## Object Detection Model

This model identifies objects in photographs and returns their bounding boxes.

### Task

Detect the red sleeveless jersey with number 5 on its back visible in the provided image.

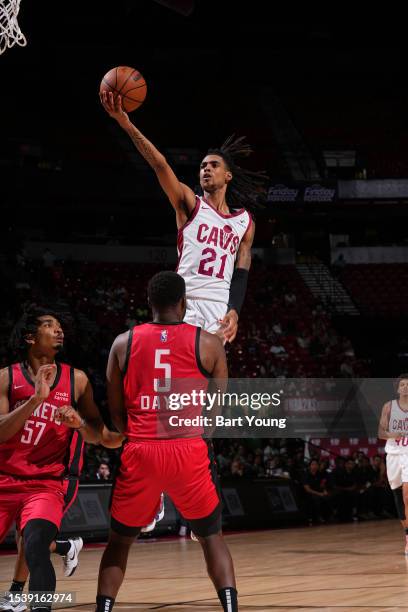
[123,322,208,440]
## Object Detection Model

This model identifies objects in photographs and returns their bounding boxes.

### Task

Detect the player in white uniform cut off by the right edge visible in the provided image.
[378,374,408,555]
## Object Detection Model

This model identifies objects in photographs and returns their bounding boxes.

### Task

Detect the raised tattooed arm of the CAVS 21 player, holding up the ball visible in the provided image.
[101,91,195,227]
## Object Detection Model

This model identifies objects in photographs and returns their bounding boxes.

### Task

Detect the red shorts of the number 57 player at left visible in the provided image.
[0,474,78,542]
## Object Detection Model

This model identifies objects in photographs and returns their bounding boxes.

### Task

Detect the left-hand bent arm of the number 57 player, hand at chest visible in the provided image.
[0,364,56,443]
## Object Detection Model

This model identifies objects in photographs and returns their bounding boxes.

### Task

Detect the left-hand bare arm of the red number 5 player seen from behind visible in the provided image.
[106,332,130,434]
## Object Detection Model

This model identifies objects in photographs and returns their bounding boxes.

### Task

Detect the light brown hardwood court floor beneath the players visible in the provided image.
[0,520,408,612]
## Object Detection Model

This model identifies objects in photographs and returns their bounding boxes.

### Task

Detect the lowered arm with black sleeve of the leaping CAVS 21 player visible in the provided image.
[221,222,255,342]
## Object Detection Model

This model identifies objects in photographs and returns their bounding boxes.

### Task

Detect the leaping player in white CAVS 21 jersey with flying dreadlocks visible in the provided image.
[101,92,266,342]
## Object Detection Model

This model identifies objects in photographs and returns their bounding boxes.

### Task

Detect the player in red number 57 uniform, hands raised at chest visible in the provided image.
[0,308,123,610]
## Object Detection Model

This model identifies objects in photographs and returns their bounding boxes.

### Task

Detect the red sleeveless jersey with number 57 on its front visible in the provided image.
[0,363,83,478]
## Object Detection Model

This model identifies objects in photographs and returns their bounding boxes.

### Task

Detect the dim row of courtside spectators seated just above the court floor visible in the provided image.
[81,438,395,525]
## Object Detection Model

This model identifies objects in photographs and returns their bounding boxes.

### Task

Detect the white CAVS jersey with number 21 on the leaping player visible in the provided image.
[177,196,252,305]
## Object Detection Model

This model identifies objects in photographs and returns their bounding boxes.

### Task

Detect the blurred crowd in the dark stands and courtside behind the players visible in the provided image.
[0,249,392,521]
